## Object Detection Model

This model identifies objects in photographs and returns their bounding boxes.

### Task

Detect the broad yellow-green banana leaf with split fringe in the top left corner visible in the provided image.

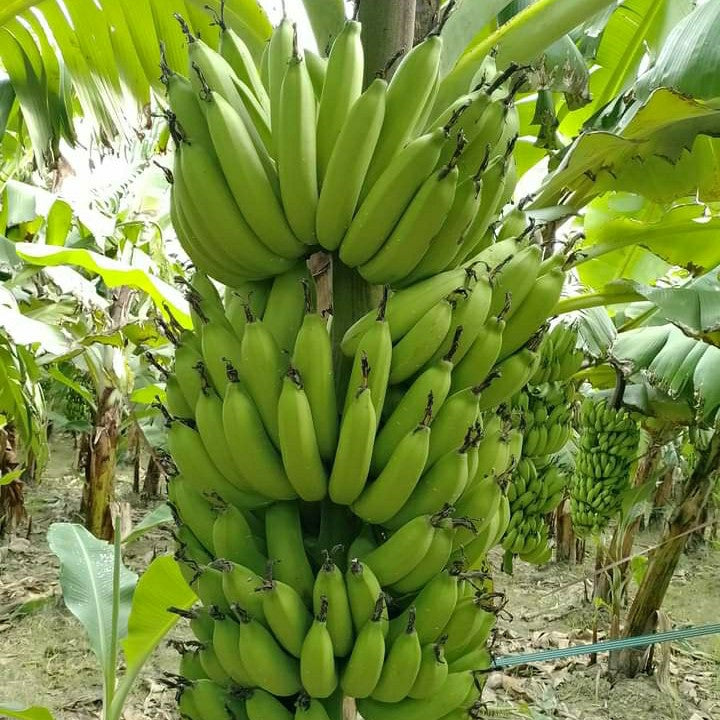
[0,0,271,163]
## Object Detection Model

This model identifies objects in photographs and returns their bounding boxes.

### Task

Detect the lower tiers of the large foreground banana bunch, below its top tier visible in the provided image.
[166,258,556,720]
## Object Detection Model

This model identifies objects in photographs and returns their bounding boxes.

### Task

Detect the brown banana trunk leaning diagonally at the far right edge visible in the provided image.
[610,431,720,677]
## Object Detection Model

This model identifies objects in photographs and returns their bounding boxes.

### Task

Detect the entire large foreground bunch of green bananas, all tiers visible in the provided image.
[160,8,564,720]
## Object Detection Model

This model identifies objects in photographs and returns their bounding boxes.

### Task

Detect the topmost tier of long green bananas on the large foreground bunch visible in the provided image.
[164,11,521,286]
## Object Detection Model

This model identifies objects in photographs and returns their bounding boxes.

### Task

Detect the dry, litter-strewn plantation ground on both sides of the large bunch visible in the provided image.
[0,438,720,720]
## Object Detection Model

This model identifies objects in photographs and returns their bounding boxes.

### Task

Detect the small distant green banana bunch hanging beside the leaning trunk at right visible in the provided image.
[570,398,640,535]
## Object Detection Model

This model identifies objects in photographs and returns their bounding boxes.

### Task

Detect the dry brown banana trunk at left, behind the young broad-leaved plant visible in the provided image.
[81,387,120,540]
